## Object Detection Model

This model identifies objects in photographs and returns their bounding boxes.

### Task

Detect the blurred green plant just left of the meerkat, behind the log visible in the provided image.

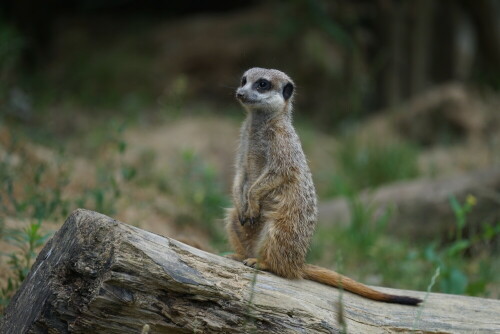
[170,149,229,247]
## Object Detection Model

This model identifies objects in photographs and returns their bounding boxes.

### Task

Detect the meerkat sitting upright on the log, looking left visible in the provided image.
[226,68,421,305]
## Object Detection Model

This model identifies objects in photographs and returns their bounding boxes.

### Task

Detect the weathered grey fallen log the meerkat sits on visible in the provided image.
[0,209,500,333]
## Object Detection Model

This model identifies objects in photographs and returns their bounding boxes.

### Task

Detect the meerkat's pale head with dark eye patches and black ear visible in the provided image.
[236,67,295,112]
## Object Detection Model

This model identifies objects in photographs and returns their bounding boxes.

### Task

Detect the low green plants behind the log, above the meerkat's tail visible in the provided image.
[309,196,500,296]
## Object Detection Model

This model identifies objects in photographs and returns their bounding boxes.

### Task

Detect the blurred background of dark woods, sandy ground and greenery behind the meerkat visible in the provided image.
[0,0,500,312]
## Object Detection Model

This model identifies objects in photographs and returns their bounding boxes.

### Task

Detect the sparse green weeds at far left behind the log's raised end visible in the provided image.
[0,123,136,314]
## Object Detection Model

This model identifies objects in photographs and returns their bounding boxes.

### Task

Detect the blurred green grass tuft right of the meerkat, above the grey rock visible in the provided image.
[322,138,418,197]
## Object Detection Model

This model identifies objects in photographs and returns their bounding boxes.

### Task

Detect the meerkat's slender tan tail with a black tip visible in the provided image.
[304,264,422,306]
